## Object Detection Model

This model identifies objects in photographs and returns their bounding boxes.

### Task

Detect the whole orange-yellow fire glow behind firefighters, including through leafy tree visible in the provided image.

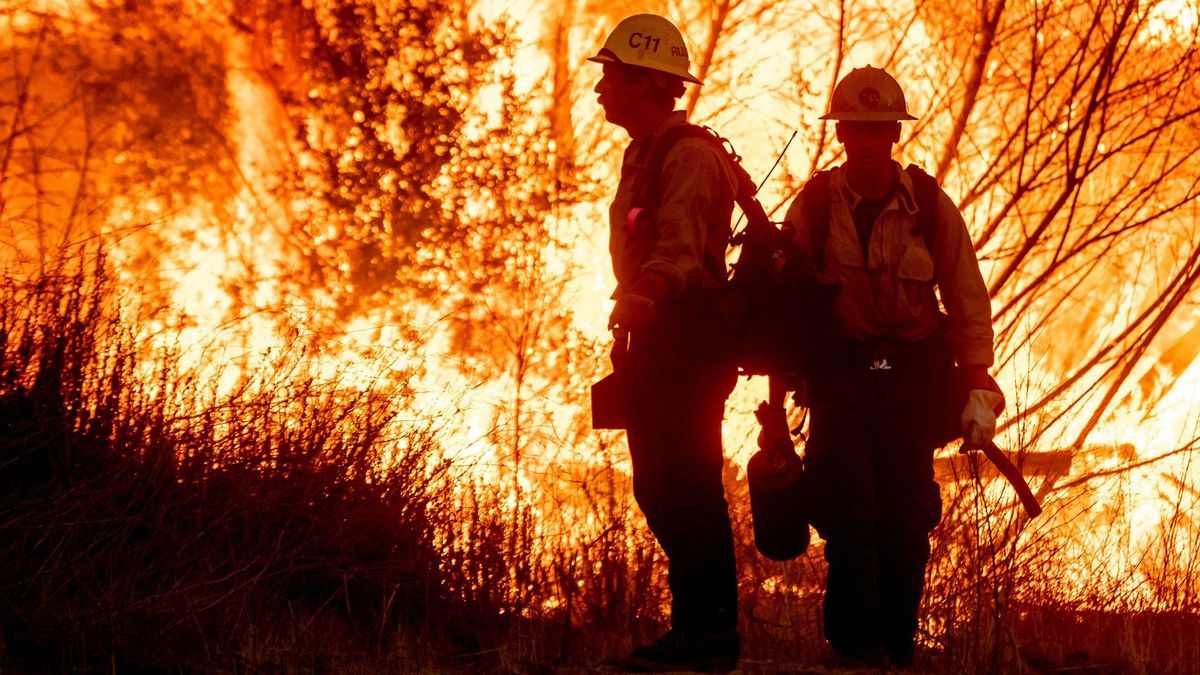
[7,0,1200,629]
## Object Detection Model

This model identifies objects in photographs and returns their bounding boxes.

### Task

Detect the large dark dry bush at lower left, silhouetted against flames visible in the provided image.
[0,258,450,671]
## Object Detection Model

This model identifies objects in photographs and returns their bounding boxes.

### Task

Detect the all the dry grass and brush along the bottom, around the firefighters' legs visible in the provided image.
[0,254,1200,673]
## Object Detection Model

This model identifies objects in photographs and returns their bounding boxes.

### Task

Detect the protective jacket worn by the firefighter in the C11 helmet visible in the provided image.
[608,110,737,298]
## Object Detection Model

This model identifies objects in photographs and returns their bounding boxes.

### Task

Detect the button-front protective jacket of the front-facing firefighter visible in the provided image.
[786,162,994,366]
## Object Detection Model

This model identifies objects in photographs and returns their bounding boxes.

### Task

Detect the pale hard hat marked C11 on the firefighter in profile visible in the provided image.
[588,14,703,84]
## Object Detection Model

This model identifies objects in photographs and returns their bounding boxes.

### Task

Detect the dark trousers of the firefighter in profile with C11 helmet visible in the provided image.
[628,302,738,633]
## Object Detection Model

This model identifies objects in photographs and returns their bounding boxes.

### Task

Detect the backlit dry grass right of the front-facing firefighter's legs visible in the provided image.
[919,460,1200,673]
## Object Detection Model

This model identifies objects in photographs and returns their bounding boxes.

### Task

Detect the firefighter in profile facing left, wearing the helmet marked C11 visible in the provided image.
[589,14,739,673]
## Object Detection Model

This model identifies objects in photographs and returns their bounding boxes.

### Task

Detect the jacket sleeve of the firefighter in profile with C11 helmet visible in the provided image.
[640,138,734,297]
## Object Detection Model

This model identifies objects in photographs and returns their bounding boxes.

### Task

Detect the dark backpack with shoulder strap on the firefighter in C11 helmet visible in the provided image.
[631,124,832,375]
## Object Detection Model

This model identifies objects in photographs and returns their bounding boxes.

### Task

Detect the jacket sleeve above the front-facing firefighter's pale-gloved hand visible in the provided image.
[934,191,995,368]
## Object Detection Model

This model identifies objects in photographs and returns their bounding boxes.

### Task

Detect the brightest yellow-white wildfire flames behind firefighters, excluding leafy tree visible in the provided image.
[4,0,1200,614]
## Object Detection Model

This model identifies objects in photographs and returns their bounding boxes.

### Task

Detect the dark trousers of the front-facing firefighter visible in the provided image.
[805,334,953,665]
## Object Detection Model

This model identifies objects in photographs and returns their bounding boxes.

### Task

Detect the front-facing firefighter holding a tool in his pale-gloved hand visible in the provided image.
[786,66,1003,668]
